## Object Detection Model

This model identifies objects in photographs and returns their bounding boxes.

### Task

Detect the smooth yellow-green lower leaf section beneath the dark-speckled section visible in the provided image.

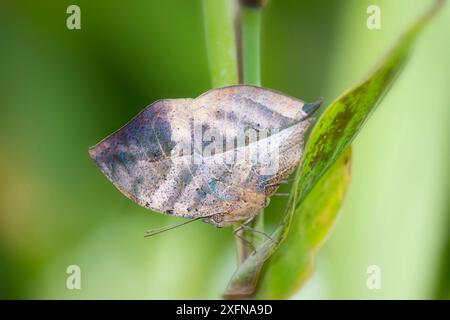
[256,148,351,299]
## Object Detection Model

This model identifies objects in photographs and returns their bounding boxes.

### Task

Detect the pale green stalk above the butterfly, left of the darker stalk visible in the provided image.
[203,0,239,88]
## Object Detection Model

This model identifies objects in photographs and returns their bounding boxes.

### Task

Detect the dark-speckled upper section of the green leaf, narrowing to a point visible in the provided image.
[300,1,442,197]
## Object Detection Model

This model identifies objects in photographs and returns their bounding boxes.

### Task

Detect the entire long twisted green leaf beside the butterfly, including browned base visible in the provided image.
[225,1,443,298]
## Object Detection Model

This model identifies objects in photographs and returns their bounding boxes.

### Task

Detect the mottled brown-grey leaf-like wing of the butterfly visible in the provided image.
[90,86,318,224]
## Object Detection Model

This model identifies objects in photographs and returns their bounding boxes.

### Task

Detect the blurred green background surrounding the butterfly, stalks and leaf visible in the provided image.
[0,0,450,299]
